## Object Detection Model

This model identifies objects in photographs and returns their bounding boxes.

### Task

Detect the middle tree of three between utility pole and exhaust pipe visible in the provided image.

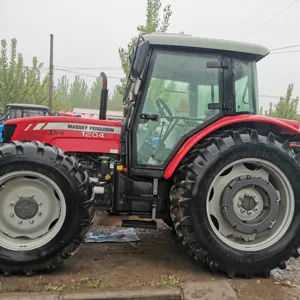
[69,75,89,108]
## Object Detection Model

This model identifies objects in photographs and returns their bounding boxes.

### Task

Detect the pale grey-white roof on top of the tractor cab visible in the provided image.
[143,32,270,61]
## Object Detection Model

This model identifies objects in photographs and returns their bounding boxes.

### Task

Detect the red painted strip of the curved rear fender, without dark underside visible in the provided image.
[164,115,300,179]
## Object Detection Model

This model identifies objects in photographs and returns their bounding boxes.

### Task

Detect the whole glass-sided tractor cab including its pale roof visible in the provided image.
[124,33,269,174]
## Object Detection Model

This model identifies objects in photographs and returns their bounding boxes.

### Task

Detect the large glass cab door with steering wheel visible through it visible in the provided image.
[132,51,223,173]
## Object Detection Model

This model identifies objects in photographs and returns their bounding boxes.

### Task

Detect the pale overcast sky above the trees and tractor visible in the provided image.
[0,0,300,108]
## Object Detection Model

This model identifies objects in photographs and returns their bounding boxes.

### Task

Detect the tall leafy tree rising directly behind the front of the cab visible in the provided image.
[117,0,172,95]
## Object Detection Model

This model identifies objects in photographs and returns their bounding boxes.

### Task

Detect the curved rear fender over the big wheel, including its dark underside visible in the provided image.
[164,115,300,179]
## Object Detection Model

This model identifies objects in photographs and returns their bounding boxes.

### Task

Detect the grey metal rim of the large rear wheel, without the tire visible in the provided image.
[206,158,295,251]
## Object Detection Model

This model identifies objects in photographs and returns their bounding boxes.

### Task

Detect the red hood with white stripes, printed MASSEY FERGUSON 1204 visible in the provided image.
[5,116,122,154]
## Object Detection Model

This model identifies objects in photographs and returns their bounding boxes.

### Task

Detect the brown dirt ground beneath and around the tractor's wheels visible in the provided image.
[0,215,300,300]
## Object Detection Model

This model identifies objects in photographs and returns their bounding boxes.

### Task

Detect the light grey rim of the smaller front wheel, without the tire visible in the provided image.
[0,171,66,251]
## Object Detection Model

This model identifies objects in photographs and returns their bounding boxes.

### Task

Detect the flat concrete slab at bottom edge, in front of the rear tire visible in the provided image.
[183,280,237,300]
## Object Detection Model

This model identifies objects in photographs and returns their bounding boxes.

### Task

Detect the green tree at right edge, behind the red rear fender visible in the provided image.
[261,83,300,121]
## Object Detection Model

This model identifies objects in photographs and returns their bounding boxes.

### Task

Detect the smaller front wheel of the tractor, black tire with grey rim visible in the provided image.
[0,141,94,275]
